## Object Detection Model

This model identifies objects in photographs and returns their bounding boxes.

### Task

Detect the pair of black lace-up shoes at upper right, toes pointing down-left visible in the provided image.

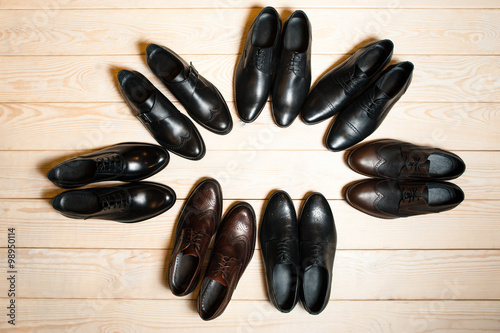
[300,39,413,152]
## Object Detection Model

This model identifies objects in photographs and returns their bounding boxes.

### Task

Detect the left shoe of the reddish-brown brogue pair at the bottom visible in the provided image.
[168,179,222,296]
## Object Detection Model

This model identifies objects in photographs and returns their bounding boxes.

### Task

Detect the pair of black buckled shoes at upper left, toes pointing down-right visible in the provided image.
[118,44,233,160]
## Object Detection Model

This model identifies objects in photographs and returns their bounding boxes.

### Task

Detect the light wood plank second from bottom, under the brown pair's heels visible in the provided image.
[0,249,500,300]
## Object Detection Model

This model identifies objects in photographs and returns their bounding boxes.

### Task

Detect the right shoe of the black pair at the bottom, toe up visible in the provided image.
[299,193,337,314]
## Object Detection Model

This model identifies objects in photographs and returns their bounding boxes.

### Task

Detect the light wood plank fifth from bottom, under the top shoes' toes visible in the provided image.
[0,101,500,150]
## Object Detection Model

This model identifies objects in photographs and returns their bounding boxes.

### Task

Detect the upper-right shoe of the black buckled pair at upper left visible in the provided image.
[146,44,233,134]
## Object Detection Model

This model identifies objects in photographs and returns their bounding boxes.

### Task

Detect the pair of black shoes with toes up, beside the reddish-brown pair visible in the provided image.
[259,191,337,314]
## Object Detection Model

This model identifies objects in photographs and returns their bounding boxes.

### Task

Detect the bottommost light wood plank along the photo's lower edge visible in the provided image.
[0,299,500,333]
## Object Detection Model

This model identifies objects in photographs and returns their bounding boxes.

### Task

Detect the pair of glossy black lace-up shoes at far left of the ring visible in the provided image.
[47,143,176,223]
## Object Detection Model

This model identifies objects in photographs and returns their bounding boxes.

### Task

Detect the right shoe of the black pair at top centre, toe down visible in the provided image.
[272,10,312,127]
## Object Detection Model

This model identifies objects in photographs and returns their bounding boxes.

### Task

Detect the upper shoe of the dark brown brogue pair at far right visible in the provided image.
[347,139,465,180]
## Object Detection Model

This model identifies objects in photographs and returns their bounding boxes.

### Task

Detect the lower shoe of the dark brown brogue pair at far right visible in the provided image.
[346,179,464,219]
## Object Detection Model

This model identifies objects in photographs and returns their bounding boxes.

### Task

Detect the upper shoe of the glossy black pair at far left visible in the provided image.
[47,142,169,188]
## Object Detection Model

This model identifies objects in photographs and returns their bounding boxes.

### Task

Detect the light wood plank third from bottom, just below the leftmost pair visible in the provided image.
[0,199,500,249]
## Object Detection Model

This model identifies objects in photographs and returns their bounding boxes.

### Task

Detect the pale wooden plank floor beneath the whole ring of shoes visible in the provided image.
[0,0,500,333]
